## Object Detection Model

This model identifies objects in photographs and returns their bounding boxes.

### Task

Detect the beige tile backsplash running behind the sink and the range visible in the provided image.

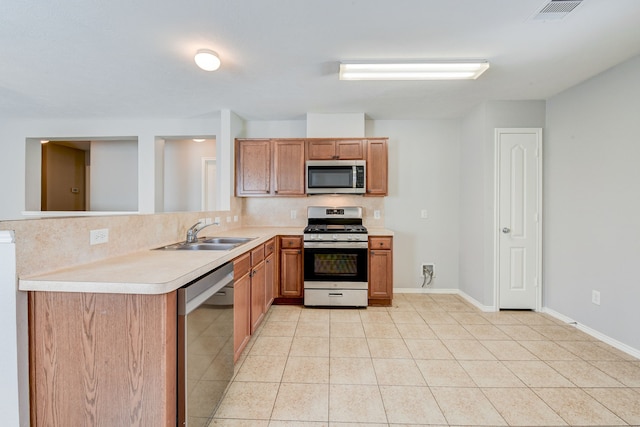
[0,195,384,277]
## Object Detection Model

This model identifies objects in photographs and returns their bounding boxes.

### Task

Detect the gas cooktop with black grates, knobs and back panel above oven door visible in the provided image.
[304,206,368,242]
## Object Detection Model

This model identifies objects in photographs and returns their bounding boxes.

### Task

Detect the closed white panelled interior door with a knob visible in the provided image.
[496,129,542,310]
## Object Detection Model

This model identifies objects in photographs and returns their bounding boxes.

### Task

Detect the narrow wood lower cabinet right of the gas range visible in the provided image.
[369,237,393,305]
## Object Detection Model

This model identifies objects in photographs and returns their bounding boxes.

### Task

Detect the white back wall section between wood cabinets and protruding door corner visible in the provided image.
[367,120,461,289]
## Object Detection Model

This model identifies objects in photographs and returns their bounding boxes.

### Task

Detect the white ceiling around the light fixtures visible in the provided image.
[0,0,640,120]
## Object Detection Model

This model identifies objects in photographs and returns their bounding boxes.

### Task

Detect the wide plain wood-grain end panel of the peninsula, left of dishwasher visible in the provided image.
[29,291,177,426]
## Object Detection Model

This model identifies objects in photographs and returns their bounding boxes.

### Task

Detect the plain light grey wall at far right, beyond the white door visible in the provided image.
[543,57,640,349]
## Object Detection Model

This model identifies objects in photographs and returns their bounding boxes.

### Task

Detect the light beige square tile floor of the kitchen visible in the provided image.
[209,294,640,427]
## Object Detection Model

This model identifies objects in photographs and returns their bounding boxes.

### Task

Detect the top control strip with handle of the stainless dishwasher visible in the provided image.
[178,263,233,316]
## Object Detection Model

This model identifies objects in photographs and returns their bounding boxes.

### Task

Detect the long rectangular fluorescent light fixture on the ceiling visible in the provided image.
[340,60,489,80]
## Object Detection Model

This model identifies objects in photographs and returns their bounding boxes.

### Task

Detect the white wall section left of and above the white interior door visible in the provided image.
[459,101,545,308]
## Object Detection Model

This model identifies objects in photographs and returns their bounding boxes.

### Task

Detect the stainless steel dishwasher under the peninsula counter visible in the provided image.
[177,263,233,426]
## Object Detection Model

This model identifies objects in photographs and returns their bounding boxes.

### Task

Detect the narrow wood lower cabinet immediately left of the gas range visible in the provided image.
[279,236,304,298]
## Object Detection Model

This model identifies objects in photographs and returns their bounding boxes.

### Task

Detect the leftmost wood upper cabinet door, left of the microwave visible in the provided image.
[236,139,271,196]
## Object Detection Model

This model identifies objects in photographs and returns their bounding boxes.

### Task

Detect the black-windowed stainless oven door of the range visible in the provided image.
[304,242,368,289]
